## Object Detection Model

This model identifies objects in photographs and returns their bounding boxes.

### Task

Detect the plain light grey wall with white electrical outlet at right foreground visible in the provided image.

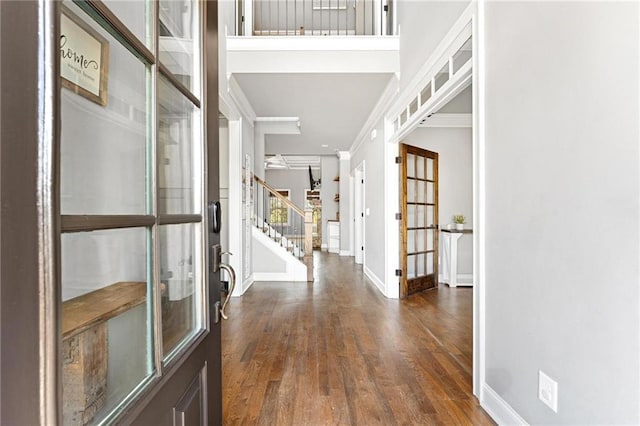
[481,2,640,425]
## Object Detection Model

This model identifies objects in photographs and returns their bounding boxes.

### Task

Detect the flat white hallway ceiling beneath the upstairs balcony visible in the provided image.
[234,74,393,155]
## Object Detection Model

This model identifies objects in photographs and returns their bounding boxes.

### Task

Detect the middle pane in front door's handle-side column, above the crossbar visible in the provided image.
[158,78,200,214]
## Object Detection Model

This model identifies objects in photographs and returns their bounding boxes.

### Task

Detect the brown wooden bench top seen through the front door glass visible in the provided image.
[62,282,147,340]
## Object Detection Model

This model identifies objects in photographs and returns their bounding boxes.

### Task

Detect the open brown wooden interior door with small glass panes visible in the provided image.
[400,144,438,297]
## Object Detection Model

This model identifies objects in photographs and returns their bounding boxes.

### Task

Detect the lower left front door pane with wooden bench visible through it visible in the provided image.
[61,228,154,424]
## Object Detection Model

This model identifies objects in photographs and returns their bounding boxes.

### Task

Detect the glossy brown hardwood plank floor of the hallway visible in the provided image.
[222,252,494,425]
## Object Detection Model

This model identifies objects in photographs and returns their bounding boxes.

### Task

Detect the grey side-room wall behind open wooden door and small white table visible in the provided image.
[404,128,473,274]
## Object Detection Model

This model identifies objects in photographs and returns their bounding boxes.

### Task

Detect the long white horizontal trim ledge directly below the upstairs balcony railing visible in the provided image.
[227,35,400,52]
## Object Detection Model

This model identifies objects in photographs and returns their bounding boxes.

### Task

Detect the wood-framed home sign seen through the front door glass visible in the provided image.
[60,8,109,106]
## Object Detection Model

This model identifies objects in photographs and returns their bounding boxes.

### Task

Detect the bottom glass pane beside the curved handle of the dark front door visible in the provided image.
[159,223,202,358]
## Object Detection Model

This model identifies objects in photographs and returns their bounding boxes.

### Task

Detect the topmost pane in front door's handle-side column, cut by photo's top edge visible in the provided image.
[158,0,200,98]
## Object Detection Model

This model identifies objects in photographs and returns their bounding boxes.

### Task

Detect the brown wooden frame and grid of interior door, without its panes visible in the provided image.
[400,144,439,298]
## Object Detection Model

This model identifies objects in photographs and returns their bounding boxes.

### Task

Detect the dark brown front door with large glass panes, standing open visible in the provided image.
[0,0,222,425]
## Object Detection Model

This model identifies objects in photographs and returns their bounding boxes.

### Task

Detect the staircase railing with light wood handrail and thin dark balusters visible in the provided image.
[252,176,313,282]
